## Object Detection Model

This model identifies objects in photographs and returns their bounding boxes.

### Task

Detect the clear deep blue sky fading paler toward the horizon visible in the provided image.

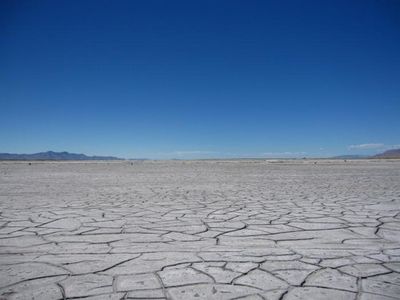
[0,0,400,158]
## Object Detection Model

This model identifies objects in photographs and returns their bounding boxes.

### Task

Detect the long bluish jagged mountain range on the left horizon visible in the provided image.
[0,151,122,160]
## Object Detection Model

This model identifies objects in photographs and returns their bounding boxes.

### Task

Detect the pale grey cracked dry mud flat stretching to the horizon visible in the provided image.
[0,160,400,300]
